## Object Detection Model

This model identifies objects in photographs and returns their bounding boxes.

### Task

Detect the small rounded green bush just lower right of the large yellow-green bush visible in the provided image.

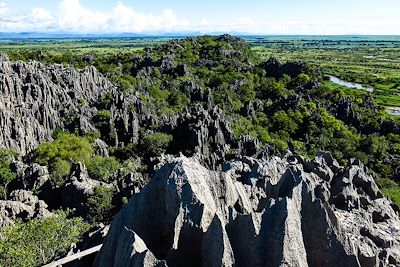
[85,156,121,182]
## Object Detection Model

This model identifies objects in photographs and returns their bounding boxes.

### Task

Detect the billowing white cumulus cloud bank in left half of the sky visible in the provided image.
[0,0,189,33]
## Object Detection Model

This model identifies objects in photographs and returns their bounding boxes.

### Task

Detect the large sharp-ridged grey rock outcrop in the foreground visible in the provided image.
[95,153,400,267]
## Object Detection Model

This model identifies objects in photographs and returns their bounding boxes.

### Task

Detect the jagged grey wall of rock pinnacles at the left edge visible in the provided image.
[0,55,114,155]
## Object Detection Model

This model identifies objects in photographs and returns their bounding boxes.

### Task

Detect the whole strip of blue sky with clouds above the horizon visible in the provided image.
[0,0,400,34]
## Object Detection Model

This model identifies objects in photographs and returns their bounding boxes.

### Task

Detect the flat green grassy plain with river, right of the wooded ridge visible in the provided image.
[247,36,400,107]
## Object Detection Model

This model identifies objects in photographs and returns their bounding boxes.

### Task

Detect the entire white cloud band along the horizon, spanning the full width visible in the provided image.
[0,0,400,35]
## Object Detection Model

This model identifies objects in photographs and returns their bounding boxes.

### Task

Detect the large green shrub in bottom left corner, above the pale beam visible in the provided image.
[0,213,90,267]
